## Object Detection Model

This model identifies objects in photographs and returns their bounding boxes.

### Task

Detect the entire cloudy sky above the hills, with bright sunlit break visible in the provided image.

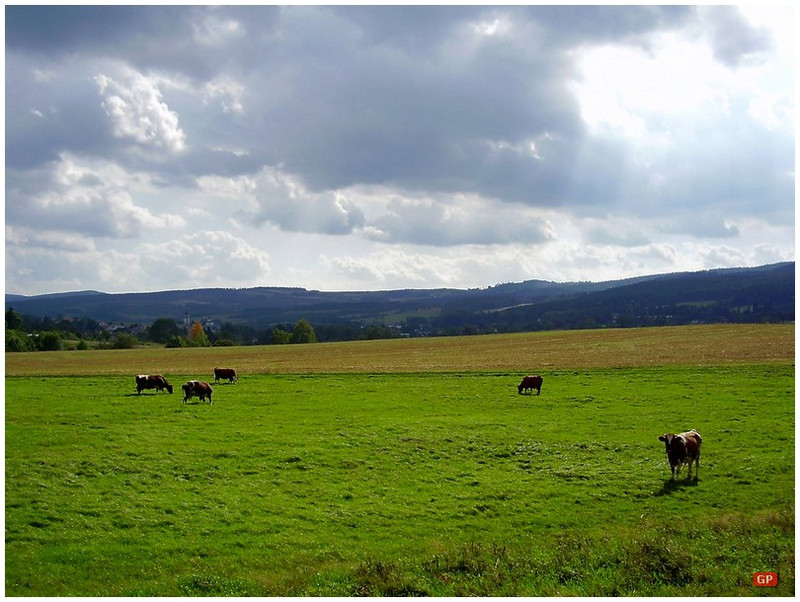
[5,5,797,295]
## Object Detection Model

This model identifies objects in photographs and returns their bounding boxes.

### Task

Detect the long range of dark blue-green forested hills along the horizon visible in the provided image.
[6,262,795,338]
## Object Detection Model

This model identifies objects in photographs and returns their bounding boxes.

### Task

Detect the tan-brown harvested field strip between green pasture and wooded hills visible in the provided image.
[6,324,795,378]
